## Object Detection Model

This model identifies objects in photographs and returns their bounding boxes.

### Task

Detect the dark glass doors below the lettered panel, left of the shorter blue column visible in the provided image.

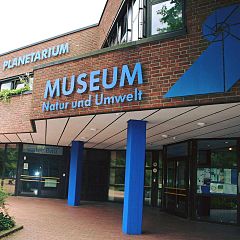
[19,155,66,198]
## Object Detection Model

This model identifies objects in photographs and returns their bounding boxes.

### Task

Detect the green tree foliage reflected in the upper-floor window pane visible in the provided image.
[157,0,183,33]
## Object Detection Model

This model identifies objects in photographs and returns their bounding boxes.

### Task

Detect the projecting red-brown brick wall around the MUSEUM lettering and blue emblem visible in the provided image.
[31,0,240,119]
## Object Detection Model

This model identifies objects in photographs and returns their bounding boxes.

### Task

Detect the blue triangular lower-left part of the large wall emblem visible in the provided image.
[164,42,224,98]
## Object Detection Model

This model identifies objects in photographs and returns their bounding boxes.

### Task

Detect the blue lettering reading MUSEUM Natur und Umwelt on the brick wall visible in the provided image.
[42,63,143,112]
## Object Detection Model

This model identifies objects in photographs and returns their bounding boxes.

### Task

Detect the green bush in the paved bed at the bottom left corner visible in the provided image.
[0,188,15,231]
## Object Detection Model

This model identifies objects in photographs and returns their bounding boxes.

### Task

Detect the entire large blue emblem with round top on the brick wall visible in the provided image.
[164,4,240,98]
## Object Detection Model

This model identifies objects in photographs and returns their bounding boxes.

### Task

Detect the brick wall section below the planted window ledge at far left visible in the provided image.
[0,94,33,133]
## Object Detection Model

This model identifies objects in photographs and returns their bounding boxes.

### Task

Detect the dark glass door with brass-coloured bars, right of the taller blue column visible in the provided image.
[164,157,188,217]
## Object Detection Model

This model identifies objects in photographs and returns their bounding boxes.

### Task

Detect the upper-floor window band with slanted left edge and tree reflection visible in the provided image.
[104,0,184,47]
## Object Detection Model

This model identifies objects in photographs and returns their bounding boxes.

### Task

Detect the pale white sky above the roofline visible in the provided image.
[0,0,106,54]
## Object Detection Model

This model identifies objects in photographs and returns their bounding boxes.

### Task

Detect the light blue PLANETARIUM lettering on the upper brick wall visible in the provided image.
[3,43,69,70]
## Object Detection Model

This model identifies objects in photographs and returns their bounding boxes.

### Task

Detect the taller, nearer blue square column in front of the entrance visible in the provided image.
[122,120,146,235]
